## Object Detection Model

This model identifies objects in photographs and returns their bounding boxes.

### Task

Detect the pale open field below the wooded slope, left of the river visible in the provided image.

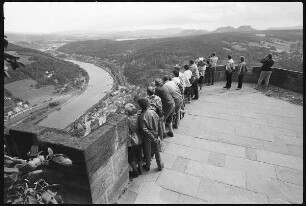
[4,79,54,106]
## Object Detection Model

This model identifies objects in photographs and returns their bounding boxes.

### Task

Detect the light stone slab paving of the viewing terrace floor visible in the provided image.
[118,82,303,204]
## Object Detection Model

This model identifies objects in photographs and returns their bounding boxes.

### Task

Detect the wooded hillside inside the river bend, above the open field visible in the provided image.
[4,44,88,86]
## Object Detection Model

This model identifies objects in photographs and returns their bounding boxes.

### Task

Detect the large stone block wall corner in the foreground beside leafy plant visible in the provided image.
[6,115,129,204]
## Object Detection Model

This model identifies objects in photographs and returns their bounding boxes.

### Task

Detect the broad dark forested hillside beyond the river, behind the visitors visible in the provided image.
[58,30,303,85]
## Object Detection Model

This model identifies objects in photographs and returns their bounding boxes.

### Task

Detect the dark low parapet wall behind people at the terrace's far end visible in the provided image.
[209,65,303,93]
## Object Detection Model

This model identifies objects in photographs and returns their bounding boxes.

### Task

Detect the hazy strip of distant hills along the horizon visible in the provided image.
[5,25,303,41]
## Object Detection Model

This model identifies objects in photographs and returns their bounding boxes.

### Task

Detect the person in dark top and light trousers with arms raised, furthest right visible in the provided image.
[254,54,274,90]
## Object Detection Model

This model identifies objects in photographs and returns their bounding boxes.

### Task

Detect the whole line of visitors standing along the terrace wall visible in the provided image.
[125,52,274,177]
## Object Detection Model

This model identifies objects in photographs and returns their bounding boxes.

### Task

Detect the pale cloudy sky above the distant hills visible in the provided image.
[4,2,303,34]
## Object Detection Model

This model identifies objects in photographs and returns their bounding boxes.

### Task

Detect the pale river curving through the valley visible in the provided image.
[38,60,113,129]
